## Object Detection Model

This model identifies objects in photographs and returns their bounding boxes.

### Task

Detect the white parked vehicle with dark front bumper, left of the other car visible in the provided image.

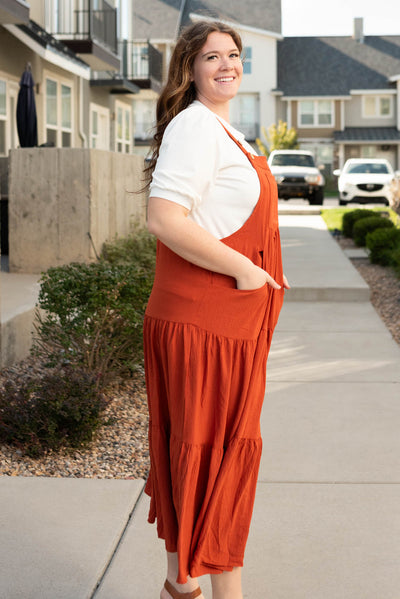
[268,150,325,204]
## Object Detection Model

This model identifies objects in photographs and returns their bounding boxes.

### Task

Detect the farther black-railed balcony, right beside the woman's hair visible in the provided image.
[119,40,163,92]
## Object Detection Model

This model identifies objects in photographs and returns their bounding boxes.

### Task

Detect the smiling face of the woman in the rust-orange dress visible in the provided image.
[192,31,243,110]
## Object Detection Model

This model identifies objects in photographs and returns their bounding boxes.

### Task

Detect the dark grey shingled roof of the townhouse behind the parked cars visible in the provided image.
[278,36,400,96]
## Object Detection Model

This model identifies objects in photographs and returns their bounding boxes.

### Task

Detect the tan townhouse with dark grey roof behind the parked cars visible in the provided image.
[273,18,400,176]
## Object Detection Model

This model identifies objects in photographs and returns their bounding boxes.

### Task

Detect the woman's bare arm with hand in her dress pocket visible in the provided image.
[147,197,286,289]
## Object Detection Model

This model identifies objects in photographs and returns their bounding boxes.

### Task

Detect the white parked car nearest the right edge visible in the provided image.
[333,158,396,206]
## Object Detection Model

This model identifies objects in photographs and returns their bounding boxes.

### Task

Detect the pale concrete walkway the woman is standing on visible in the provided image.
[0,214,400,599]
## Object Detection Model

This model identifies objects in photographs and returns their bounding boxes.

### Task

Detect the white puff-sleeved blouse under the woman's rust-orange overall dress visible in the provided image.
[150,100,260,239]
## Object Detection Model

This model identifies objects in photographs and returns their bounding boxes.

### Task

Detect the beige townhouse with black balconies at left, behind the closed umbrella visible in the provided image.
[0,0,144,156]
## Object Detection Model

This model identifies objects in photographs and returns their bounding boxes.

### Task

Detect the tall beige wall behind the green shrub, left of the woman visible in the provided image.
[9,148,146,273]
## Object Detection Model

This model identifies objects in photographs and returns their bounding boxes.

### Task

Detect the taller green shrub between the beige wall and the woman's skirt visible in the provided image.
[33,261,153,387]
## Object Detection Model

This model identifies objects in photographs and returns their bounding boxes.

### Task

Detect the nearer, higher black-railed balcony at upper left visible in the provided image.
[50,0,120,71]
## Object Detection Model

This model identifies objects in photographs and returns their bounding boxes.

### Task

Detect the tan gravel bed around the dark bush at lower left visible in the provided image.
[0,368,149,479]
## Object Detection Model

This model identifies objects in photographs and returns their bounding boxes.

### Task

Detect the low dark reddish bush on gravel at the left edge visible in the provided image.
[0,368,106,457]
